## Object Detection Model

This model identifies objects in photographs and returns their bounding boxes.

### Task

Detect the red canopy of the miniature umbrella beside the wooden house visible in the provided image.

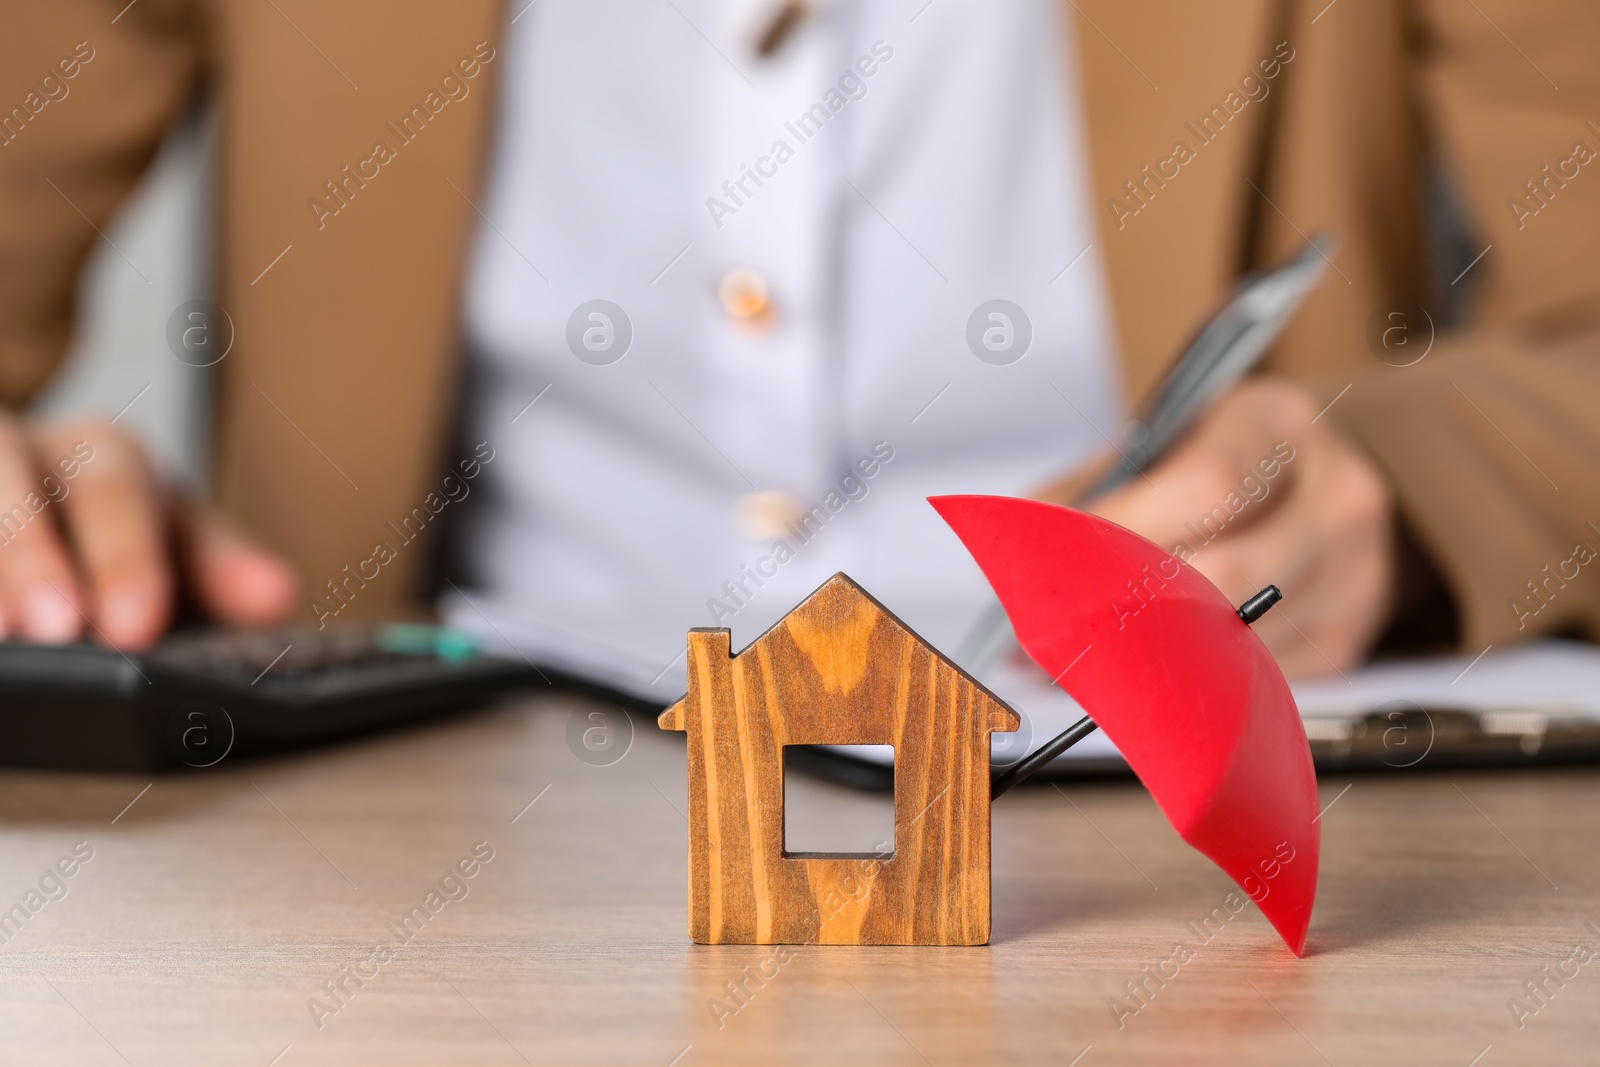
[928,496,1318,955]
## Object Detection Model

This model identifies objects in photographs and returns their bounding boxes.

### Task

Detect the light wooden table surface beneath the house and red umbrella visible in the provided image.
[0,696,1600,1067]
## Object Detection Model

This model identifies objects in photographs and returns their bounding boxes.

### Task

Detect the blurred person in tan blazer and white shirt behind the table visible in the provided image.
[0,0,1600,697]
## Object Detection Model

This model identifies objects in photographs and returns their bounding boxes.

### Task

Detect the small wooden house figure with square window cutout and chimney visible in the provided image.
[658,574,1019,945]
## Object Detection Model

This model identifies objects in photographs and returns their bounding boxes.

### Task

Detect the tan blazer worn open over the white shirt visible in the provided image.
[0,0,1600,648]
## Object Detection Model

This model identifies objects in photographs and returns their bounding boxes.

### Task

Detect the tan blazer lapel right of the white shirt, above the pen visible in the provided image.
[1062,0,1275,402]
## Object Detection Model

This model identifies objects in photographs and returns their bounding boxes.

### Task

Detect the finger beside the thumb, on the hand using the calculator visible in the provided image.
[35,422,173,649]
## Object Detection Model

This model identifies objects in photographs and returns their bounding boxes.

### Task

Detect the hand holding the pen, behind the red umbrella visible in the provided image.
[1042,378,1395,677]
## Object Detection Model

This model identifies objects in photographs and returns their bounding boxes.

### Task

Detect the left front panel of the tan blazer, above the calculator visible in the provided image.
[214,0,504,617]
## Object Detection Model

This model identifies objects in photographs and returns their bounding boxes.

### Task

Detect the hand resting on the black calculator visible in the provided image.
[0,413,296,651]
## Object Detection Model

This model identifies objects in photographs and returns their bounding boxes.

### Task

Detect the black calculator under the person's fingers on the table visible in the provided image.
[0,624,547,771]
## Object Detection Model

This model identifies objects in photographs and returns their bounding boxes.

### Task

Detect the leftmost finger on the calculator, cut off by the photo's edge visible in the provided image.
[0,418,83,643]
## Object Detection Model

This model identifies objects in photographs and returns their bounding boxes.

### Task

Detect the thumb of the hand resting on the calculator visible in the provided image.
[176,501,299,625]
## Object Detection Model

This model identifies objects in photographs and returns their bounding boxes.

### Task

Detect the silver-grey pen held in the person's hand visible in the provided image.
[955,234,1334,677]
